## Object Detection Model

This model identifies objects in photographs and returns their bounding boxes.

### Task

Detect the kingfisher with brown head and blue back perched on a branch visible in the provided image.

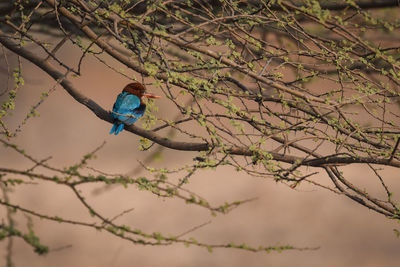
[110,82,160,135]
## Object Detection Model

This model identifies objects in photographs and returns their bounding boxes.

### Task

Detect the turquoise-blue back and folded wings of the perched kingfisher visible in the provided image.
[112,92,143,123]
